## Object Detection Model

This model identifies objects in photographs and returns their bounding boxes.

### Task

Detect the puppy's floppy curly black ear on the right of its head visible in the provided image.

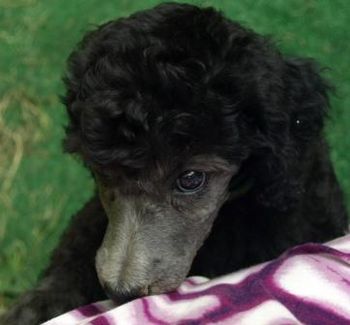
[251,59,330,211]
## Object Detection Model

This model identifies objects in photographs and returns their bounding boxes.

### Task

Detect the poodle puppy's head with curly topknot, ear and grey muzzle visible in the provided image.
[65,4,326,299]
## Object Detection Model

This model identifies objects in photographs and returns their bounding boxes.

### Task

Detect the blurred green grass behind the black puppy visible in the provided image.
[0,0,350,310]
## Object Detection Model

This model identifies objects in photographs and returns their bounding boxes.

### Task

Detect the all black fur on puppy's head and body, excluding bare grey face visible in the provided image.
[2,4,346,324]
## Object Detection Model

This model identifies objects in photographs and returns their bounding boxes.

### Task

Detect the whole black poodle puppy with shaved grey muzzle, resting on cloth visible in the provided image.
[5,4,347,325]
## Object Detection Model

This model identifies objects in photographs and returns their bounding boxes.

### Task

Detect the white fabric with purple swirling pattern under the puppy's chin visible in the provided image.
[45,235,350,325]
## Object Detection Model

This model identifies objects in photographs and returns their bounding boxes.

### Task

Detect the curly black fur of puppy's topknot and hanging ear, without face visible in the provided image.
[61,5,328,209]
